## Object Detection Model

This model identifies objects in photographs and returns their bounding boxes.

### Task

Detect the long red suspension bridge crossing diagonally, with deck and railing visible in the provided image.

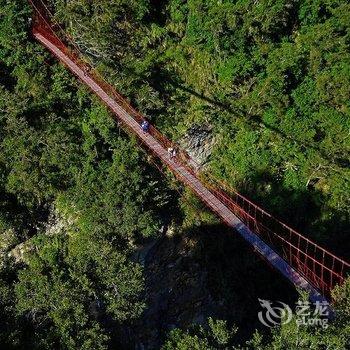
[29,0,350,301]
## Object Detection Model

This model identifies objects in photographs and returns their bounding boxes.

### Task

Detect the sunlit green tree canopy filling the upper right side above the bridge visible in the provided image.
[44,0,350,249]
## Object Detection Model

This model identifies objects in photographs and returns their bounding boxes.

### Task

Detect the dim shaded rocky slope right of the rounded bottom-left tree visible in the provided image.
[127,231,221,350]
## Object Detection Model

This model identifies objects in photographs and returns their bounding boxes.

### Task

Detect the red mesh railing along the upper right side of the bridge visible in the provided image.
[29,0,350,297]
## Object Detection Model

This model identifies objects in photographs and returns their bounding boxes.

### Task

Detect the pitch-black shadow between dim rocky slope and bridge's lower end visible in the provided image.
[191,225,298,342]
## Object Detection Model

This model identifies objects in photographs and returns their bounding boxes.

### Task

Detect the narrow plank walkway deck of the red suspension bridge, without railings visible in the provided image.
[34,31,325,301]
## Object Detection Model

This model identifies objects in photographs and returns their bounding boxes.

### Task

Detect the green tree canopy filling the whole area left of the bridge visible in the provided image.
[0,1,169,349]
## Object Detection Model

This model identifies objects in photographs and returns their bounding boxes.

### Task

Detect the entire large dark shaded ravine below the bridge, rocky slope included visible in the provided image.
[127,224,297,349]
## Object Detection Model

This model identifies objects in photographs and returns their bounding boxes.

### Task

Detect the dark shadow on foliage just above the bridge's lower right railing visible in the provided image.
[238,171,350,259]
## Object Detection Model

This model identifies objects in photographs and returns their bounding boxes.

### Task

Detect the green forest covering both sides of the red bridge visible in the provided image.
[0,0,350,350]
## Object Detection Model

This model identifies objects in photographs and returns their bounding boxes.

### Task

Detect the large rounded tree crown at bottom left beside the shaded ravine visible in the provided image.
[15,232,143,349]
